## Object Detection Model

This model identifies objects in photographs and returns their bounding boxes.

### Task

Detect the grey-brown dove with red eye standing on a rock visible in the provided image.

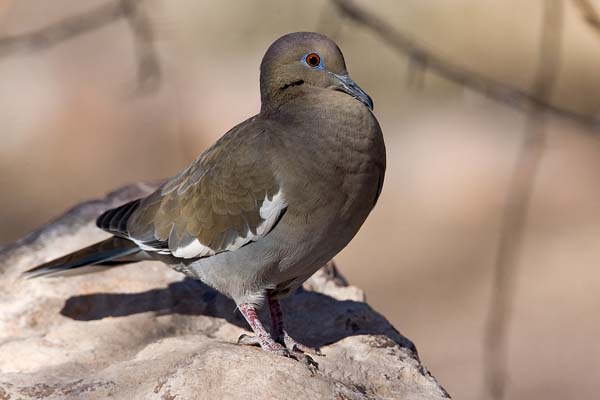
[26,32,385,358]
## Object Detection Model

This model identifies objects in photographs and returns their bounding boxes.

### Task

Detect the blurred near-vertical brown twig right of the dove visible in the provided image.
[484,0,563,400]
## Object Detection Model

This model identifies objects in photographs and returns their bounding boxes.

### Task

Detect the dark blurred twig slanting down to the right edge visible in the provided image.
[331,0,600,129]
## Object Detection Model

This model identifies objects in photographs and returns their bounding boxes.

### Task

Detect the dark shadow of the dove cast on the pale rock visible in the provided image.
[60,278,417,357]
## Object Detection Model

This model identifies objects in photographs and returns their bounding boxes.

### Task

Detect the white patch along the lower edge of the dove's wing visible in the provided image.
[172,189,287,258]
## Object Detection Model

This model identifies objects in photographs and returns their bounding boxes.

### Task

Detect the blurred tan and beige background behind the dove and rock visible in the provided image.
[0,0,600,399]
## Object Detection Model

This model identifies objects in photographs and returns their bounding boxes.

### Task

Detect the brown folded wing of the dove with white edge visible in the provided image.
[98,120,286,258]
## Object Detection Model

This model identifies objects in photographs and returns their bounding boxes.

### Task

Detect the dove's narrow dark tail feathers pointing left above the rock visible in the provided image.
[23,236,140,278]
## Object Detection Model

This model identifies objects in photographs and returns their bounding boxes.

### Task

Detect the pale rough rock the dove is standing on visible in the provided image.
[0,185,448,400]
